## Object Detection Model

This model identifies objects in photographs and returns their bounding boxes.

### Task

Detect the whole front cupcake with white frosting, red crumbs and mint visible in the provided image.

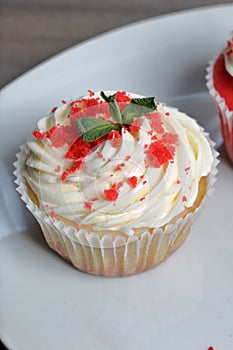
[15,91,217,276]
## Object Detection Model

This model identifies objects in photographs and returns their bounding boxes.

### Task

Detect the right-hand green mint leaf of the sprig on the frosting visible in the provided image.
[122,97,157,124]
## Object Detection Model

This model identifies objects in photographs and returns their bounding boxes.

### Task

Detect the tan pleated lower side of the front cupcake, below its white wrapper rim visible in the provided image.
[40,211,190,277]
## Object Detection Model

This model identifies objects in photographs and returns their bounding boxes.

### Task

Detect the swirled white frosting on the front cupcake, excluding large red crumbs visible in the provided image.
[24,94,213,234]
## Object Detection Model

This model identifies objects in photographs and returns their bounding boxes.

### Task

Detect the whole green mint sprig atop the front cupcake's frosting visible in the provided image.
[75,91,157,142]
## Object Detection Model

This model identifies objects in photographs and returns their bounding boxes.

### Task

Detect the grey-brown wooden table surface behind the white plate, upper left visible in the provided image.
[0,0,229,87]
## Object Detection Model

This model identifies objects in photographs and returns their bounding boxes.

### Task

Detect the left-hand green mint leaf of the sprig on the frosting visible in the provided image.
[74,117,120,142]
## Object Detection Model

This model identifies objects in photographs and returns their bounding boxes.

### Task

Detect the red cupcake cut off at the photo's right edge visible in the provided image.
[206,34,233,163]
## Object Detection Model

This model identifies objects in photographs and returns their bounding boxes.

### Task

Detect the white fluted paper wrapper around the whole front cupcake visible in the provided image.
[14,139,218,276]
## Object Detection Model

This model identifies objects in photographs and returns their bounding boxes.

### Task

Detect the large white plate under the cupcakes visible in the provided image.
[0,5,233,350]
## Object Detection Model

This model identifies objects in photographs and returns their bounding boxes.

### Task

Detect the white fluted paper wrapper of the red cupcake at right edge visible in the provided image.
[206,57,233,163]
